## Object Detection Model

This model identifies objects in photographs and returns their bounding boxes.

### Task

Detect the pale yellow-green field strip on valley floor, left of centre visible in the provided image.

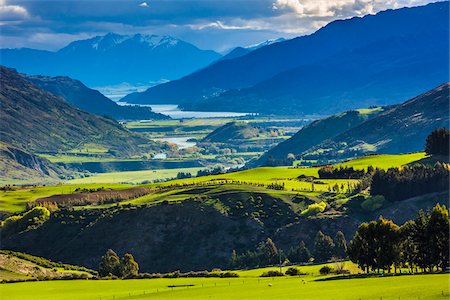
[68,168,201,184]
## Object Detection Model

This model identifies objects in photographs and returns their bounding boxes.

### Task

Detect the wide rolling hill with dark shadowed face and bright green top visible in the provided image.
[0,153,442,272]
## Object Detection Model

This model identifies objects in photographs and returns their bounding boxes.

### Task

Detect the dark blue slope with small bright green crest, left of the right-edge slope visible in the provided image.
[249,108,384,166]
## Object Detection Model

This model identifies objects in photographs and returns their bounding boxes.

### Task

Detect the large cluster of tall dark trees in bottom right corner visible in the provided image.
[348,204,450,272]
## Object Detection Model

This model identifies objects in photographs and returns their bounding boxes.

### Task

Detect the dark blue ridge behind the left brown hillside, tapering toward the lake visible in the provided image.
[25,75,168,120]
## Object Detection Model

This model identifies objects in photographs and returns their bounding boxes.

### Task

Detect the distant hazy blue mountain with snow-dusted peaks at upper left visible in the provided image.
[0,33,221,86]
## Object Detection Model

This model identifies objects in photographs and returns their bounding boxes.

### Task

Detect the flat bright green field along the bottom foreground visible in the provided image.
[0,274,450,300]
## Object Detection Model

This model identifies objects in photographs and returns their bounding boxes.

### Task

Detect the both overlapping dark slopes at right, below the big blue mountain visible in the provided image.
[255,83,450,166]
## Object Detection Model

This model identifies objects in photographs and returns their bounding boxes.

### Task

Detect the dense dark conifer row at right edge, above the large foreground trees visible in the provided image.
[370,162,450,201]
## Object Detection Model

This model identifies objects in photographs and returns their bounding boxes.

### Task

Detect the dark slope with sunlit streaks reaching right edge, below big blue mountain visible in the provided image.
[304,83,450,159]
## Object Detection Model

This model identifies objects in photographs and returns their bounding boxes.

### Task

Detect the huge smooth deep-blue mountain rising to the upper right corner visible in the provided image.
[125,1,449,113]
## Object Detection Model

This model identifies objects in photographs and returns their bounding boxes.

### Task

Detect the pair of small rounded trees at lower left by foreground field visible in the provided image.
[98,249,139,278]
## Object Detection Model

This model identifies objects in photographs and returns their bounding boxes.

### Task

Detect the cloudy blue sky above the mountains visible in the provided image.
[0,0,436,52]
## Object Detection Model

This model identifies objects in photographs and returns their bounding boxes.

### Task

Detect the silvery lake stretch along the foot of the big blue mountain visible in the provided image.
[117,102,250,119]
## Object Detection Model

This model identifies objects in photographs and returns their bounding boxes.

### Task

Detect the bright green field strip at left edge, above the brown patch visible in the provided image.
[0,184,130,212]
